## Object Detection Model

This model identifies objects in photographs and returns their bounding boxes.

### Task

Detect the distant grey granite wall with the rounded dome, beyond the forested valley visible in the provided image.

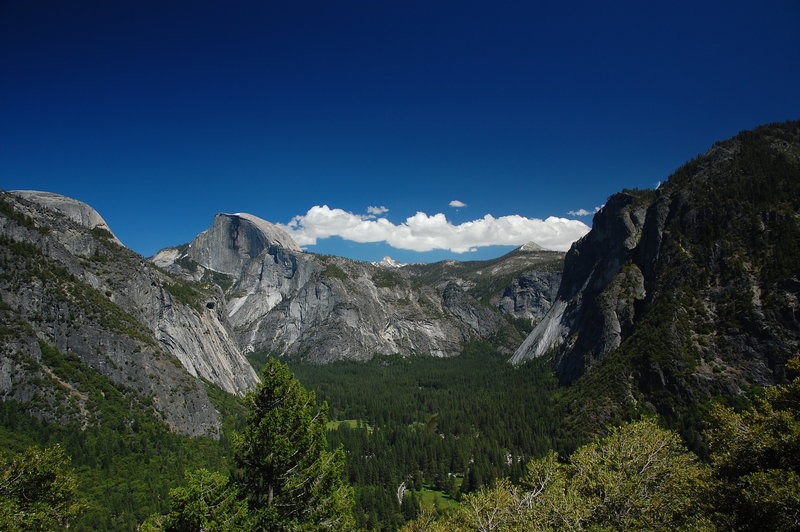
[152,214,561,363]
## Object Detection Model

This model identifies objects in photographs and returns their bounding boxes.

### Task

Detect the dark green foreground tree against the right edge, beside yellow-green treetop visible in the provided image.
[706,358,800,531]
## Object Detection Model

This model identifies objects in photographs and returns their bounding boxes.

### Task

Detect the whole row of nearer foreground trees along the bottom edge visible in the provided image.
[0,353,800,532]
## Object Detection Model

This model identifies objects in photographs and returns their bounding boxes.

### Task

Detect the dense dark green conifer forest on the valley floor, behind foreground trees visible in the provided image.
[0,343,559,530]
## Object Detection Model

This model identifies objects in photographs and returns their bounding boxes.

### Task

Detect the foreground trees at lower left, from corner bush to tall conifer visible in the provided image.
[0,360,354,532]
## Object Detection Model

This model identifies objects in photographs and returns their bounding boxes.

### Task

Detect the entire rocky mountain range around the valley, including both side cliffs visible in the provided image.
[0,122,800,435]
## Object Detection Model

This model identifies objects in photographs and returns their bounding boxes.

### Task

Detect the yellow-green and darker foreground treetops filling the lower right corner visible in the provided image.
[403,358,800,532]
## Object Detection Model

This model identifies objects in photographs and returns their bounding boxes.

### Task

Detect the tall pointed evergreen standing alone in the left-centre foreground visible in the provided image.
[236,359,352,530]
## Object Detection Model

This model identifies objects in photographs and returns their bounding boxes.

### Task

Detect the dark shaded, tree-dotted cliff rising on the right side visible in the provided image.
[512,122,800,420]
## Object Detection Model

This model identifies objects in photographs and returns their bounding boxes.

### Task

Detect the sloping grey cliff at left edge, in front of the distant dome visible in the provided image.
[0,192,257,436]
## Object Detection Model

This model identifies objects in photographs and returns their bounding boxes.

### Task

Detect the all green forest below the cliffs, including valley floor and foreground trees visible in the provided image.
[0,344,800,531]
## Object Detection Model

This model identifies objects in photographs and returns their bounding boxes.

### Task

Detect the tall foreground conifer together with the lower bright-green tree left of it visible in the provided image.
[148,359,353,531]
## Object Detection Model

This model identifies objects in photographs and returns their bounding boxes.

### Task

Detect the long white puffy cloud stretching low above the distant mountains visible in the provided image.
[281,205,589,253]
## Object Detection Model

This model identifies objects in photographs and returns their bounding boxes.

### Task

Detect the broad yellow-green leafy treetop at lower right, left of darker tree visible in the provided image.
[406,420,713,531]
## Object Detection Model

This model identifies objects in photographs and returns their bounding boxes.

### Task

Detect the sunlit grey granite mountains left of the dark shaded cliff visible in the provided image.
[0,191,563,436]
